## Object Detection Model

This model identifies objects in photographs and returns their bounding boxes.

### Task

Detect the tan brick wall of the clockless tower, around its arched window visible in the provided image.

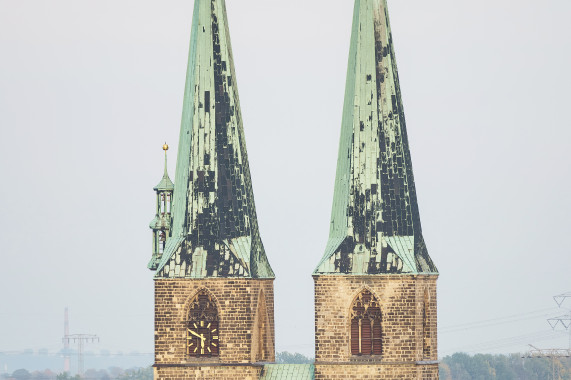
[313,275,438,380]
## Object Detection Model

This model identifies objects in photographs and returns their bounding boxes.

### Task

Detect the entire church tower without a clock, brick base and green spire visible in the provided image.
[313,0,438,379]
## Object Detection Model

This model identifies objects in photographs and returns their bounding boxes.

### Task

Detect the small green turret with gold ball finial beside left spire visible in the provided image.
[148,143,174,270]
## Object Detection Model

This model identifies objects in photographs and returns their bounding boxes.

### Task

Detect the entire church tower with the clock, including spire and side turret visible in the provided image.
[149,0,275,380]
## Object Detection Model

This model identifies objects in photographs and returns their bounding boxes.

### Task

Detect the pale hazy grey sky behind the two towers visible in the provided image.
[0,0,571,364]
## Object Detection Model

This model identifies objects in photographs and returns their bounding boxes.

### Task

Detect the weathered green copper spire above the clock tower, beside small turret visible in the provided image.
[156,0,274,278]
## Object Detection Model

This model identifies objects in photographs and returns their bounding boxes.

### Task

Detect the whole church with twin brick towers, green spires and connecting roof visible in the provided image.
[149,0,438,380]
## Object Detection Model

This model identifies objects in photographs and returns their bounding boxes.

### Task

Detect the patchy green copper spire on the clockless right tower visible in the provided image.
[314,0,437,274]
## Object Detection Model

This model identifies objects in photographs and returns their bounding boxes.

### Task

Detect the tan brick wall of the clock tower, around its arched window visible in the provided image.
[155,278,275,380]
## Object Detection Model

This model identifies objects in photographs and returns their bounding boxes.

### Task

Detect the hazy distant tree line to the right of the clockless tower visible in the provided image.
[440,353,571,380]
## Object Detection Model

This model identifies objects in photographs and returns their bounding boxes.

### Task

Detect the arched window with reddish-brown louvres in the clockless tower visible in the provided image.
[351,290,383,355]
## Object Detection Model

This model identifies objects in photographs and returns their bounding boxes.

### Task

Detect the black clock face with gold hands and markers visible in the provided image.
[186,320,219,357]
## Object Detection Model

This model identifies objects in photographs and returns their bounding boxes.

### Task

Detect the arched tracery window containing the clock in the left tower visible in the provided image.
[186,290,220,357]
